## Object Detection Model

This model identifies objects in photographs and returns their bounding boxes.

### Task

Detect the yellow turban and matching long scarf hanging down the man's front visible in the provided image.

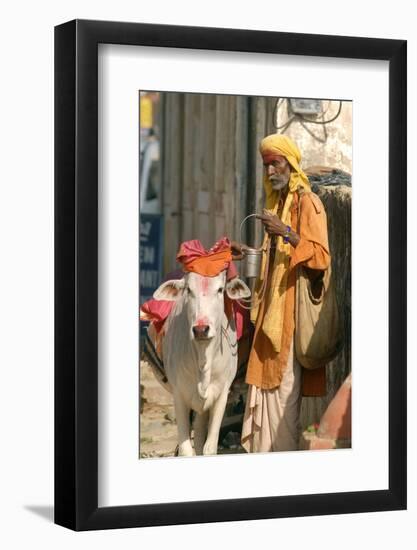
[251,134,310,352]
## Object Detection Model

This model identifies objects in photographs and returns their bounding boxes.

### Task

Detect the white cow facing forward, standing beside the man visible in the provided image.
[154,272,250,456]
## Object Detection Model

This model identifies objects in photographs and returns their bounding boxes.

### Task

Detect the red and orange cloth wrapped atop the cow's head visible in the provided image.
[177,237,232,277]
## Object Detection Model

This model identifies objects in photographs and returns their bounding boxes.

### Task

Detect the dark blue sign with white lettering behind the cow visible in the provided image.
[139,214,163,305]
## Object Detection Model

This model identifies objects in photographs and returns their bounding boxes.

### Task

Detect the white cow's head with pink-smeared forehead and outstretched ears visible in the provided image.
[153,271,250,340]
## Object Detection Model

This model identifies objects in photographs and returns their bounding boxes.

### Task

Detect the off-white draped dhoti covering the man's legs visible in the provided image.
[242,346,301,453]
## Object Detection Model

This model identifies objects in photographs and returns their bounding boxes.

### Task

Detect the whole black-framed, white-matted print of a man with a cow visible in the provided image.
[55,20,406,530]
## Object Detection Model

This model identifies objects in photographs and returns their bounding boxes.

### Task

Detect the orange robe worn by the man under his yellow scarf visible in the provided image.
[246,193,330,396]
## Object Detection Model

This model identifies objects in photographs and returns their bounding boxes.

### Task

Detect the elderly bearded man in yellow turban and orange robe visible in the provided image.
[233,134,330,452]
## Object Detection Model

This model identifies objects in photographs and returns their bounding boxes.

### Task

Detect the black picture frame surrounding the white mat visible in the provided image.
[55,20,407,530]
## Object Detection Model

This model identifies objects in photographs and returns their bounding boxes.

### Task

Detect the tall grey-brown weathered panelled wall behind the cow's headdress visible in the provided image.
[161,93,274,273]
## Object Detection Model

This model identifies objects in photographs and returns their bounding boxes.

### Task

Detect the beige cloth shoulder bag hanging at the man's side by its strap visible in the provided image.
[294,193,343,369]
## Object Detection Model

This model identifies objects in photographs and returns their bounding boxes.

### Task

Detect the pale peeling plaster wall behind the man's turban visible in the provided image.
[276,99,352,174]
